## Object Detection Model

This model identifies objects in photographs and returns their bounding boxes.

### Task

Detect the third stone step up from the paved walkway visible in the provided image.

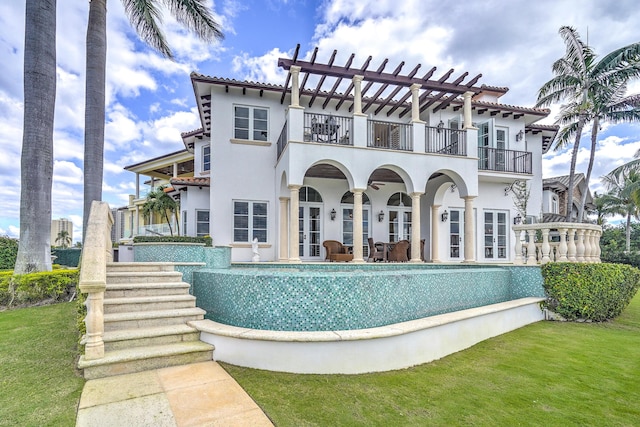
[104,307,206,332]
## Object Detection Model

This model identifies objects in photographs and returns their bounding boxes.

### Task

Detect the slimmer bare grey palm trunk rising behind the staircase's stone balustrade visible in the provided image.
[82,0,107,240]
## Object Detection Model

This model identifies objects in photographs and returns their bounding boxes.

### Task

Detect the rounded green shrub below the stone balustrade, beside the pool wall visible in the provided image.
[542,262,640,322]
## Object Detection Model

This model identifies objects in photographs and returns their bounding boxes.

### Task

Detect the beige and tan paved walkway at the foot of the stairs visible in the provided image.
[76,362,273,427]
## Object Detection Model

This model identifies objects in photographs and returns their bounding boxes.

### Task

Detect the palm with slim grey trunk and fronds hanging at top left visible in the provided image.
[82,0,224,237]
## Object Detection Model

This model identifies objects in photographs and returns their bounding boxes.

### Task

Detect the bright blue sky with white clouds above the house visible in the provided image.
[0,0,640,240]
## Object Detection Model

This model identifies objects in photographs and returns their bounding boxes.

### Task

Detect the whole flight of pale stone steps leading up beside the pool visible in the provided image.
[78,263,213,379]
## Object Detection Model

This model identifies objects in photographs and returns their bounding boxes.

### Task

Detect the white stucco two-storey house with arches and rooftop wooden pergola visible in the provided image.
[124,45,557,263]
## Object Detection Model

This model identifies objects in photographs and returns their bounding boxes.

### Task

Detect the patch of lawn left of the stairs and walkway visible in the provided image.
[0,302,84,426]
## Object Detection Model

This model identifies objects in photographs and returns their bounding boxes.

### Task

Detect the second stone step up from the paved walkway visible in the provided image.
[102,324,200,351]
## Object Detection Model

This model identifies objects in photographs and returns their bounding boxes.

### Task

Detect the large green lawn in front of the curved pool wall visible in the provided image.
[224,294,640,426]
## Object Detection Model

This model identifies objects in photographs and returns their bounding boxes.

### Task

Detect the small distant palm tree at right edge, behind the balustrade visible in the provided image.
[601,171,640,252]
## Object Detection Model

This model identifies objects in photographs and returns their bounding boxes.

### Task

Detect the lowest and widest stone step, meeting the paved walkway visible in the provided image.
[78,341,213,380]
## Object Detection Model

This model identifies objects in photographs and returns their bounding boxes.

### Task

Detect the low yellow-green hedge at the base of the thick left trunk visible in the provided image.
[0,270,78,307]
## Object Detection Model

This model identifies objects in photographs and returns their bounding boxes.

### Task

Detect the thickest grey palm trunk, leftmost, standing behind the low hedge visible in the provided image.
[14,0,56,274]
